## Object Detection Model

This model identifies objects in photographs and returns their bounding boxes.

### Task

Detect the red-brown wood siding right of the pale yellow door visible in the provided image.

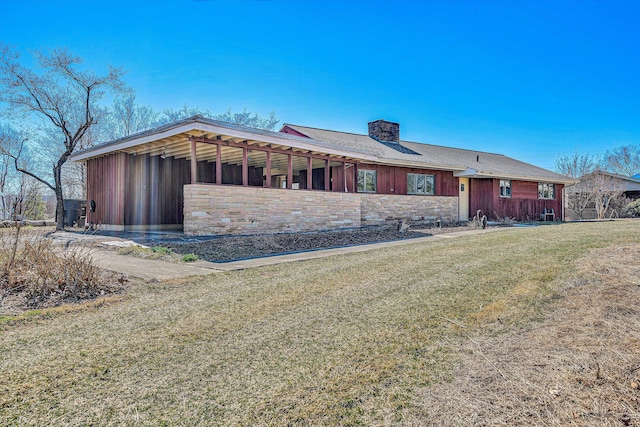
[469,178,563,221]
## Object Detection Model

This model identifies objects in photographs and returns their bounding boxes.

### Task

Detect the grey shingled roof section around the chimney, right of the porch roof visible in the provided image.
[283,124,575,183]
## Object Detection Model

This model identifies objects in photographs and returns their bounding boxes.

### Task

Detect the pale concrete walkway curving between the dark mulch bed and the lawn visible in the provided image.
[50,227,507,280]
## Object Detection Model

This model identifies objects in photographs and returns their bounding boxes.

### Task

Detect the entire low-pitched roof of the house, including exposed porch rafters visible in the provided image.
[71,116,575,184]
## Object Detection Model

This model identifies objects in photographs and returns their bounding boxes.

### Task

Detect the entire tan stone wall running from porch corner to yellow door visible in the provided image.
[184,184,458,235]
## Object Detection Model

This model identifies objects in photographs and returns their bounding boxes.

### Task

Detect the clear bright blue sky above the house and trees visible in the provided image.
[0,0,640,169]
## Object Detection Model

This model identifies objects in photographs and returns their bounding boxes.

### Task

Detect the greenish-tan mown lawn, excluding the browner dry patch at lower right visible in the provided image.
[0,221,640,426]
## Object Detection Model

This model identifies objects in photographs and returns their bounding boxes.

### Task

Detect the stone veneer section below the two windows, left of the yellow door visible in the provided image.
[361,194,458,225]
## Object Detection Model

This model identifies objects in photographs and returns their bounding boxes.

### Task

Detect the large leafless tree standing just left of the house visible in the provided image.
[0,44,124,230]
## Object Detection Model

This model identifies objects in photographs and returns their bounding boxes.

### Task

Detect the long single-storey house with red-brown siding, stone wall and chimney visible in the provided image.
[72,116,572,234]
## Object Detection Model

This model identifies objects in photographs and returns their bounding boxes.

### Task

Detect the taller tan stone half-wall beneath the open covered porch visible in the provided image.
[184,184,360,235]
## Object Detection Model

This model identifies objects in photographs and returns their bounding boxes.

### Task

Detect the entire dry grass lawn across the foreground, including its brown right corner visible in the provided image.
[0,221,640,426]
